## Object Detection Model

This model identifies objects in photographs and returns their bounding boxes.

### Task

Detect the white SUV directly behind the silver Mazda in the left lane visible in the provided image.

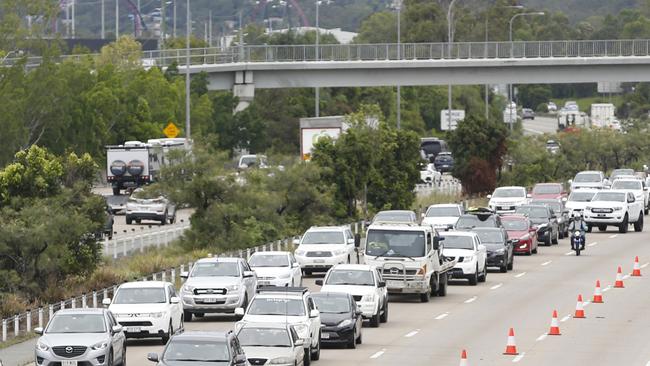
[102,281,183,344]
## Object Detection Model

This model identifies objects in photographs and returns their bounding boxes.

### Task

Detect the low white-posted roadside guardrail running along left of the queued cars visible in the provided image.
[0,222,365,342]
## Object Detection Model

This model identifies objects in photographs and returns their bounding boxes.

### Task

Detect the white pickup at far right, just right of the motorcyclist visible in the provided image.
[584,190,643,233]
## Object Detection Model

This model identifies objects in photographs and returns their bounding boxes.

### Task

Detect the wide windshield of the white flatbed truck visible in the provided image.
[366,229,425,257]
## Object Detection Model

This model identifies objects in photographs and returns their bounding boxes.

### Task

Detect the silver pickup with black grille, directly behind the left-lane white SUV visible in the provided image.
[181,258,257,322]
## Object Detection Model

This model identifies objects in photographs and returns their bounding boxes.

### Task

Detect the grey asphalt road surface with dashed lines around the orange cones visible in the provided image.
[119,229,650,366]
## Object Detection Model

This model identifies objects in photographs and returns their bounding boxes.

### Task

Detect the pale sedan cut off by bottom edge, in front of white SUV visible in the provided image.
[237,323,305,366]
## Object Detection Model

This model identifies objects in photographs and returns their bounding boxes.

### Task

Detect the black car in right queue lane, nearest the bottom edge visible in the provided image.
[311,292,363,348]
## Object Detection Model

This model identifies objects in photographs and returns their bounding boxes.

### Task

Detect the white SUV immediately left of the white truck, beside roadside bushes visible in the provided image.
[295,226,354,275]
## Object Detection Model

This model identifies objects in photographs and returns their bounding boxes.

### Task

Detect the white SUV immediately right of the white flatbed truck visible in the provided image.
[442,231,487,286]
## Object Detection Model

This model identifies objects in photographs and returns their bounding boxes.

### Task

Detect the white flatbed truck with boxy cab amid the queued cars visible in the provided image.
[365,222,455,302]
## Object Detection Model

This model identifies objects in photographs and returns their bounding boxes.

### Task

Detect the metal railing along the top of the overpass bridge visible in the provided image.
[4,39,650,68]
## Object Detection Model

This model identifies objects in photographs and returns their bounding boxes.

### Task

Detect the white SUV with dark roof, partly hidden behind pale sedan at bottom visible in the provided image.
[235,287,321,365]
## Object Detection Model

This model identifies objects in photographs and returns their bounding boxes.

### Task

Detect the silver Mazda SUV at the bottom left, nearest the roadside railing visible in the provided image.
[34,309,126,366]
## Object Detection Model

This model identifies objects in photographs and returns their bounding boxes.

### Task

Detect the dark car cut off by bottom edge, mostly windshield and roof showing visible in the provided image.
[147,331,248,366]
